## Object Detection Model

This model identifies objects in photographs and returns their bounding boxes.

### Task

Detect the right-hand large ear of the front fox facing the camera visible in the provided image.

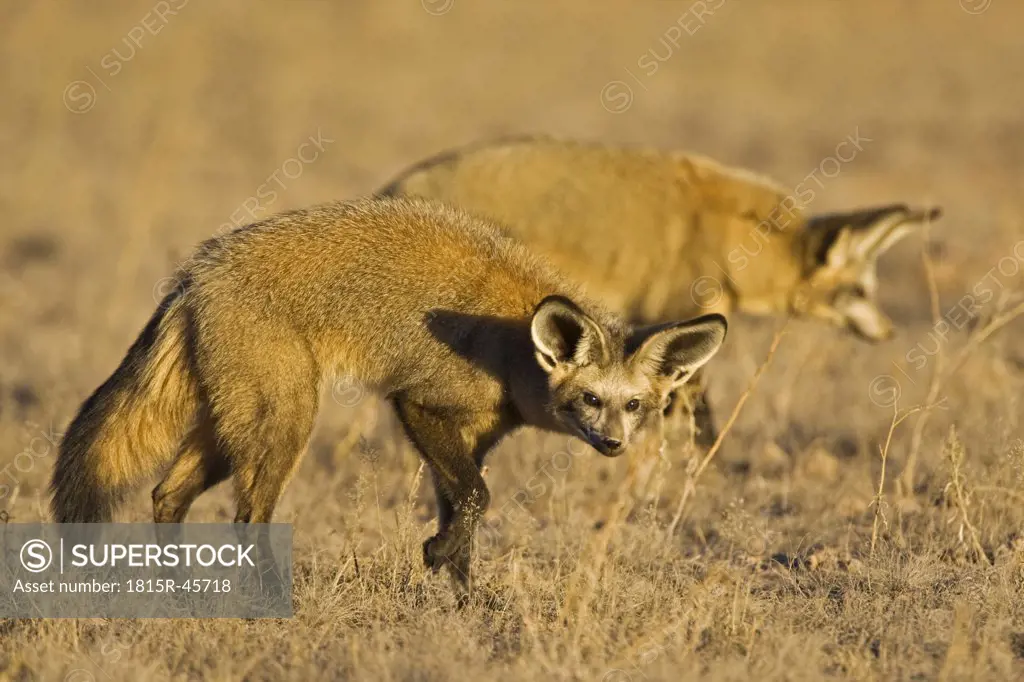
[630,314,728,388]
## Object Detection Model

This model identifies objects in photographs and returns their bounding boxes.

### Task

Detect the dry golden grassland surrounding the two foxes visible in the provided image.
[0,0,1024,682]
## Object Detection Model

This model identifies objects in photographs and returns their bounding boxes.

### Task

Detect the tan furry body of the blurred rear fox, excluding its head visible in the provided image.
[382,137,937,323]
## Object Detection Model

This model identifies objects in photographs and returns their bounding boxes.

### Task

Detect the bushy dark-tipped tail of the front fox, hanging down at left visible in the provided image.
[50,291,199,523]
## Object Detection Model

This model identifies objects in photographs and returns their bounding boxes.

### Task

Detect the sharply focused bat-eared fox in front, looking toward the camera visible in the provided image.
[51,199,726,587]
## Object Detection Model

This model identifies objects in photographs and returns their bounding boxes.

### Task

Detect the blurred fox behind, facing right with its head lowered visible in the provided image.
[379,136,941,449]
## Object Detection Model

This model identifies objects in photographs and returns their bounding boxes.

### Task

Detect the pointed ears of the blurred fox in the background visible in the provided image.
[808,204,942,267]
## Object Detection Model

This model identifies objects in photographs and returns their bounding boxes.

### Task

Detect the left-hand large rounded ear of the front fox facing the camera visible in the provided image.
[529,296,608,372]
